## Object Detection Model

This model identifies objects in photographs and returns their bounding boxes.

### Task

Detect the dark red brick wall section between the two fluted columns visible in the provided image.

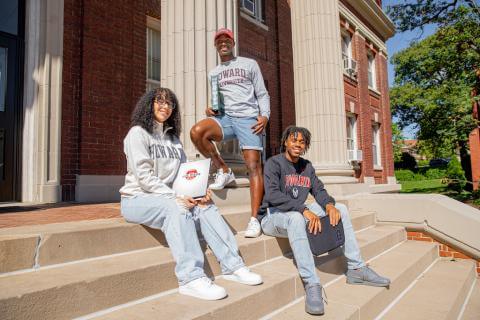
[238,0,295,157]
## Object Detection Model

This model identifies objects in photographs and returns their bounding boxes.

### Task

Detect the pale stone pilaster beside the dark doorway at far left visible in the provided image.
[22,0,63,202]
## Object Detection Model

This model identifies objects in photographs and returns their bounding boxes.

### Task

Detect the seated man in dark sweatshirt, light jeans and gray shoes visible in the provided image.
[258,126,390,314]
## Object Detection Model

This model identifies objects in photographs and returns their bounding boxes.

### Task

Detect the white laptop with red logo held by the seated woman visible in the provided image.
[172,159,210,199]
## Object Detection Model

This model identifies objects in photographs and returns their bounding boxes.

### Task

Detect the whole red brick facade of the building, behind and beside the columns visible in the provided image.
[61,0,393,201]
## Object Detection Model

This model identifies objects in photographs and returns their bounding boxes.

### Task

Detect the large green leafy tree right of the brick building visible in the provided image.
[388,0,480,157]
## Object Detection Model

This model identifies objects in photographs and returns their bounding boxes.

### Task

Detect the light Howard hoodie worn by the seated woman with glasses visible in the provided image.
[120,122,186,198]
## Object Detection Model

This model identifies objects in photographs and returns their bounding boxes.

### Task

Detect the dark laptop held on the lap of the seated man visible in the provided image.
[307,216,345,256]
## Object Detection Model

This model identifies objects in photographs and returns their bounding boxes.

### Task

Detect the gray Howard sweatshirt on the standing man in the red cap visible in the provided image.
[208,57,270,118]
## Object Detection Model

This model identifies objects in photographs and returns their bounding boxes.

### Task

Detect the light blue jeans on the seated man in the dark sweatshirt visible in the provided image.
[262,202,365,284]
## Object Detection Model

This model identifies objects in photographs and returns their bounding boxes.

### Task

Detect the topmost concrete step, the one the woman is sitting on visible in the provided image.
[0,206,375,274]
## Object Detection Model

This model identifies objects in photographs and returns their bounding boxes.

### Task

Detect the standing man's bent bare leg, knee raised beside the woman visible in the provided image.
[190,119,228,172]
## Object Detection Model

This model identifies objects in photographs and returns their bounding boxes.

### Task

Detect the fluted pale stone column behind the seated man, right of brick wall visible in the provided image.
[290,0,356,183]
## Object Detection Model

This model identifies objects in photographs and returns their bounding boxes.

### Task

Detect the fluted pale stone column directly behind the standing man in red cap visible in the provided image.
[161,0,237,159]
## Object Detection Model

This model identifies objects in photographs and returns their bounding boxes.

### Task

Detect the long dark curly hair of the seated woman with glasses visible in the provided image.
[130,88,182,137]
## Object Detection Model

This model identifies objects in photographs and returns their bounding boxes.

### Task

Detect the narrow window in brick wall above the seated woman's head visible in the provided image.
[146,17,161,91]
